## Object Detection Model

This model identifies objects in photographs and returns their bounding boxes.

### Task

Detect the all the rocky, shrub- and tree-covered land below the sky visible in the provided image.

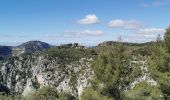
[0,27,170,100]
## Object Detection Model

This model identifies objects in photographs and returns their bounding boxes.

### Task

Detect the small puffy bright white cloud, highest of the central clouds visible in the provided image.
[78,14,100,25]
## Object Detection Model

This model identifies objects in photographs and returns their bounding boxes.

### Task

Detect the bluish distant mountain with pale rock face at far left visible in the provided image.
[0,41,52,60]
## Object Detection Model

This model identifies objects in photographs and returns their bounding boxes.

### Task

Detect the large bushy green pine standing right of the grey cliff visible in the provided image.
[92,42,130,100]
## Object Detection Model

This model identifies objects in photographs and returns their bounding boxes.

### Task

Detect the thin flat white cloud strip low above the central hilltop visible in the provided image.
[64,30,105,37]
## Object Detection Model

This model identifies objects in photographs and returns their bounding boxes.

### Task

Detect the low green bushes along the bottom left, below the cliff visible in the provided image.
[0,86,77,100]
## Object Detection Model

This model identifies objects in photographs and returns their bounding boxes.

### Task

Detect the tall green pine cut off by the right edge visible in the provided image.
[149,27,170,99]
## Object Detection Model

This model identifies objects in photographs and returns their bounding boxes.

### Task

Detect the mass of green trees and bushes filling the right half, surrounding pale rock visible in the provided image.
[82,27,170,100]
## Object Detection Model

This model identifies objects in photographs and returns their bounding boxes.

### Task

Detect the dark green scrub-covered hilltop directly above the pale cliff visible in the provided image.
[42,48,95,64]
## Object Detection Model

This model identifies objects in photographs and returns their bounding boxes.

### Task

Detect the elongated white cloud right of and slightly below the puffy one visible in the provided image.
[108,19,142,30]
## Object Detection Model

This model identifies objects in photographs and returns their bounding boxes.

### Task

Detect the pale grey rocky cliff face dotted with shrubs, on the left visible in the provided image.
[0,45,93,97]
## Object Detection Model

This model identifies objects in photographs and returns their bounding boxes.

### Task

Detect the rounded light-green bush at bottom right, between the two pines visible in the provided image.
[124,81,163,100]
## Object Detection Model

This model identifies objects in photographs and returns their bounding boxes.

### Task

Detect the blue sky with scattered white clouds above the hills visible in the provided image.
[0,0,170,45]
